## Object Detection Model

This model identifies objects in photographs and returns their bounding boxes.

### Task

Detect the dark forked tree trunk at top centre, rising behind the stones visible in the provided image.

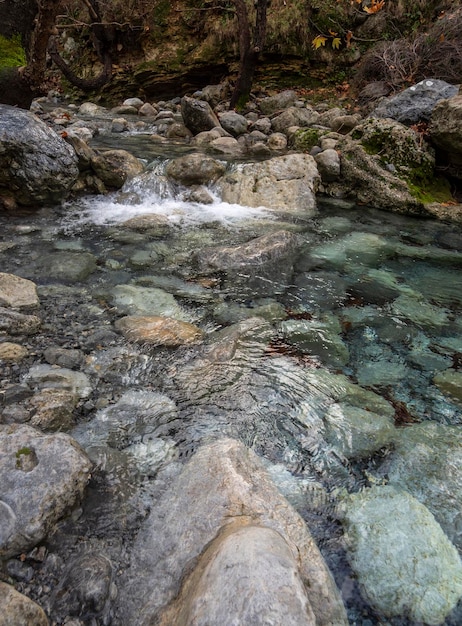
[230,0,268,109]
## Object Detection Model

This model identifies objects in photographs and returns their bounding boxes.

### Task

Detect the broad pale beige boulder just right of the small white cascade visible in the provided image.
[217,154,320,217]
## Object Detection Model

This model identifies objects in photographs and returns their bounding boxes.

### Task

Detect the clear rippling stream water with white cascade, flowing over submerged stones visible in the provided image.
[0,138,462,626]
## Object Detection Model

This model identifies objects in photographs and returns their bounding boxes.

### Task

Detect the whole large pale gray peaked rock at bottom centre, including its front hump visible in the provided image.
[118,439,348,626]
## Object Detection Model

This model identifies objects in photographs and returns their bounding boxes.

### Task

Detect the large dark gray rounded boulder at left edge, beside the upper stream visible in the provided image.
[0,105,79,206]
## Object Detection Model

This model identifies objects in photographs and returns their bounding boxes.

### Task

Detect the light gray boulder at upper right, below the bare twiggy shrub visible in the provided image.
[370,78,459,126]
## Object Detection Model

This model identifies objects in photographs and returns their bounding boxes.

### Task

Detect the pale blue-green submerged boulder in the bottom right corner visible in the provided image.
[342,485,462,626]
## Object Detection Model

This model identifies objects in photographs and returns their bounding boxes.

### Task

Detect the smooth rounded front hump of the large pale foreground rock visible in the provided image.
[162,526,317,626]
